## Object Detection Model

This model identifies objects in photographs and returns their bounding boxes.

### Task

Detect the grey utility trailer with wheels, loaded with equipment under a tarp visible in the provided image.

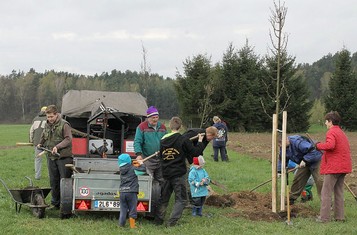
[60,90,160,217]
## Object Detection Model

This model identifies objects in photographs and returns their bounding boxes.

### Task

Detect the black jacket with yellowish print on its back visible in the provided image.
[160,133,205,179]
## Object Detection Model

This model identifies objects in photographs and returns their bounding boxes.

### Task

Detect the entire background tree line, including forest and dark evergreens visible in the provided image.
[0,45,357,132]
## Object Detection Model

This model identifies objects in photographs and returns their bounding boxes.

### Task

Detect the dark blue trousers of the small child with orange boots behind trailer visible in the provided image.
[119,192,138,226]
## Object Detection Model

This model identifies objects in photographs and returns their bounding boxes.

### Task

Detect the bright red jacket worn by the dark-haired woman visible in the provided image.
[316,126,352,175]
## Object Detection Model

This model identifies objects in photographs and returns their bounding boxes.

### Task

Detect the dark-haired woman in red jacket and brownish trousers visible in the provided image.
[316,111,352,223]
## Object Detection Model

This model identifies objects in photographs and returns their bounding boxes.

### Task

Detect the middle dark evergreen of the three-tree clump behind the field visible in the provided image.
[215,42,264,131]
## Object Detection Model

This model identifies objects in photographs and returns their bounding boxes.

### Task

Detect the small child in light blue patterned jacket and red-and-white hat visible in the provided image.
[188,156,210,216]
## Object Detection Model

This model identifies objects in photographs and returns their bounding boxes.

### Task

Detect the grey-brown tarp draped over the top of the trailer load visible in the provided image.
[61,90,148,118]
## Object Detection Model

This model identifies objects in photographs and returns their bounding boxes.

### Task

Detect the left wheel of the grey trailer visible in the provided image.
[60,178,73,219]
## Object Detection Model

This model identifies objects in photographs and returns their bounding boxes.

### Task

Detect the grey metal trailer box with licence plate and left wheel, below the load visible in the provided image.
[61,158,153,216]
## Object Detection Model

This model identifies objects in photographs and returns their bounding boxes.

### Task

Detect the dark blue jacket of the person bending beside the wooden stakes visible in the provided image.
[280,135,322,169]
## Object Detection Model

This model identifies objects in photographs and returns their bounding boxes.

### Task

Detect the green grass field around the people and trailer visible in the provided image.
[0,125,357,235]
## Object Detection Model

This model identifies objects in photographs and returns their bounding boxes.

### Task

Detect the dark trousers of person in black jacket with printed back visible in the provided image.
[157,175,187,225]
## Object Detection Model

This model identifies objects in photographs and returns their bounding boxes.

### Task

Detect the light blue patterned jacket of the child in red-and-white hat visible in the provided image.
[188,166,210,197]
